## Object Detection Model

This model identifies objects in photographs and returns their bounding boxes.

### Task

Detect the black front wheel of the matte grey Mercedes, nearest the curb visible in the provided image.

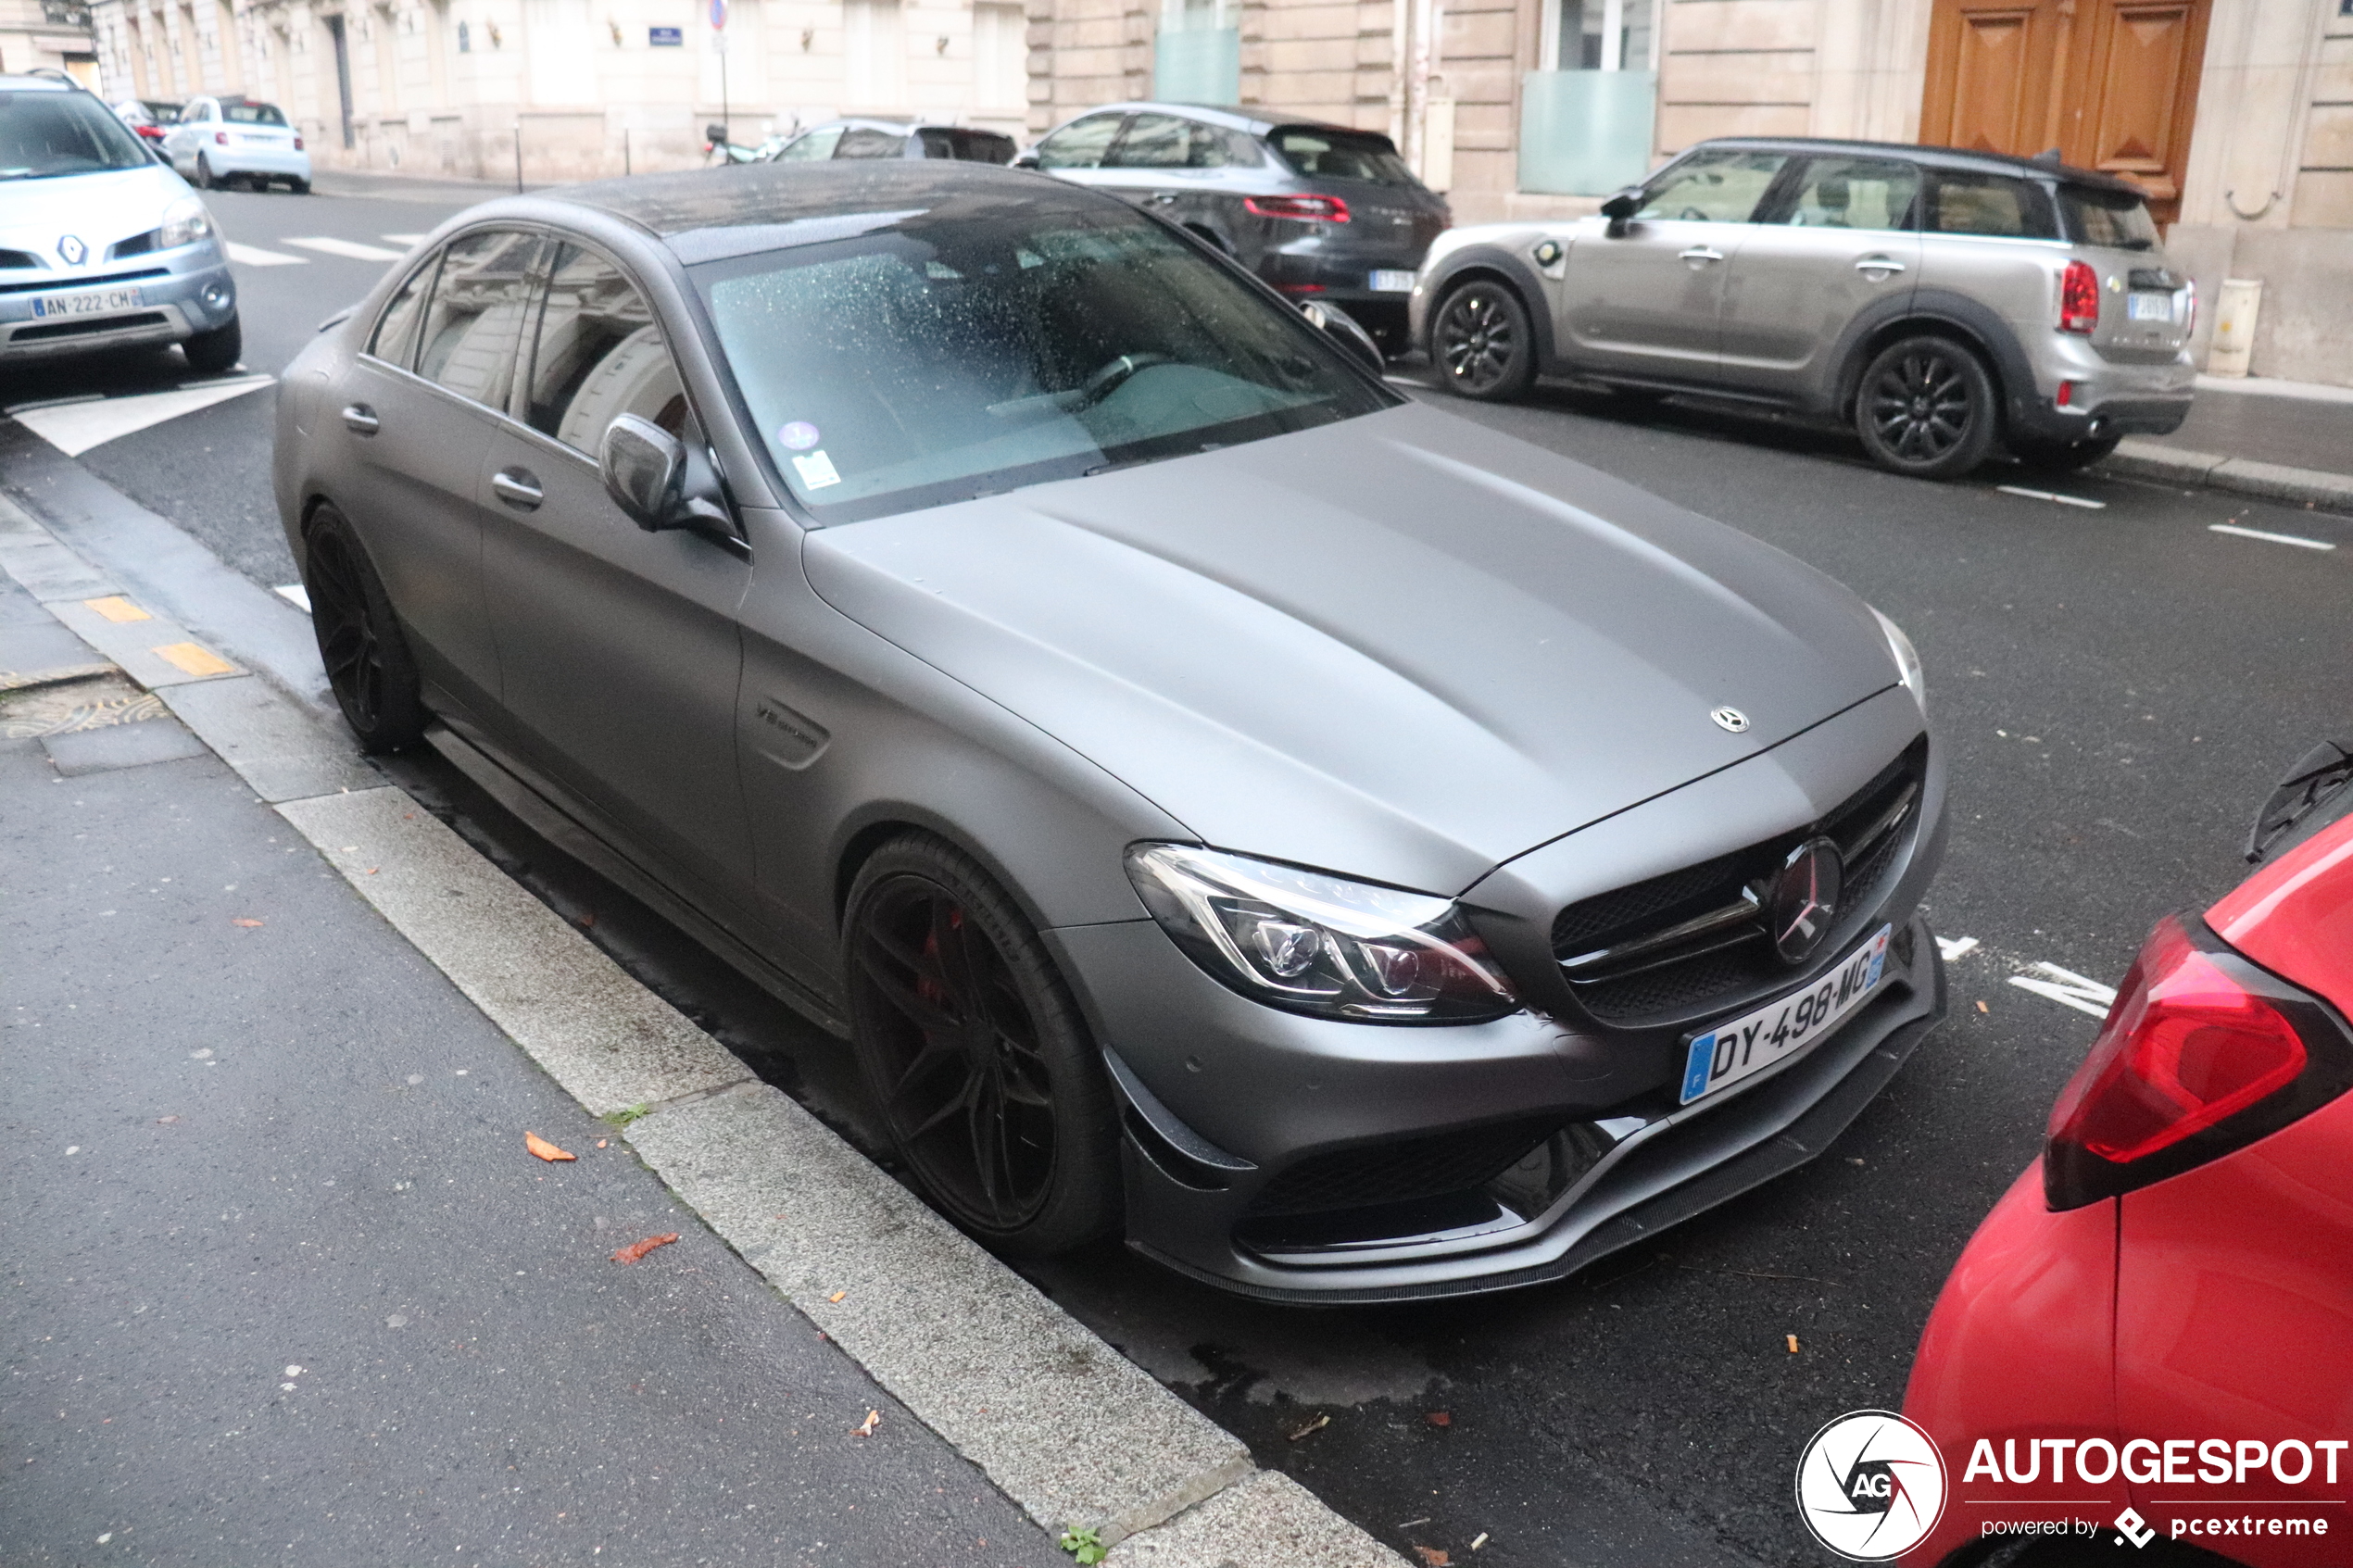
[842,833,1120,1258]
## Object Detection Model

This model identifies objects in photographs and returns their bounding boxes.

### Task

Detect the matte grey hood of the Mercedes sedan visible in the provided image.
[802,405,1894,894]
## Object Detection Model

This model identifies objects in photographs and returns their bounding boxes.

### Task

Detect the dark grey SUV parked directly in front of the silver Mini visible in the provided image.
[1019,104,1454,353]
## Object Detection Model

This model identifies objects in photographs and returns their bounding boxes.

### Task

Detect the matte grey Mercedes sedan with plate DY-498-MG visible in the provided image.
[275,162,1944,1302]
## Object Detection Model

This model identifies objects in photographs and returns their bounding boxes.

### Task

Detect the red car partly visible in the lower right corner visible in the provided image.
[1904,746,2353,1568]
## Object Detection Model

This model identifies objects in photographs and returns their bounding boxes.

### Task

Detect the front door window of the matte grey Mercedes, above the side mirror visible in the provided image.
[524,242,687,456]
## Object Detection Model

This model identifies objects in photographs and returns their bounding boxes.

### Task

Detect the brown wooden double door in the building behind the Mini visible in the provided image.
[1920,0,2212,223]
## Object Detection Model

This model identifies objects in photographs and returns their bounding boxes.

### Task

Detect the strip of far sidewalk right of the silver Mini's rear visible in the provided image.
[2101,376,2353,510]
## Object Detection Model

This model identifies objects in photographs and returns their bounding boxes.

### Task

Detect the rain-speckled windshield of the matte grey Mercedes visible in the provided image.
[692,205,1395,524]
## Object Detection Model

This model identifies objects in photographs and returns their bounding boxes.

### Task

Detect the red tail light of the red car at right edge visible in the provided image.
[2043,914,2353,1209]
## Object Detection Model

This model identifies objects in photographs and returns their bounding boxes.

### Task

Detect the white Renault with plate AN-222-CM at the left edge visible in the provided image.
[0,75,245,371]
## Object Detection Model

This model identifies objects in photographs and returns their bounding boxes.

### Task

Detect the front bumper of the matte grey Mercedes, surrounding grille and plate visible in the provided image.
[1047,689,1944,1305]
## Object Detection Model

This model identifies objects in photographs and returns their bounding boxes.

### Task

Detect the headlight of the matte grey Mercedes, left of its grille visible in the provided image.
[1127,844,1520,1022]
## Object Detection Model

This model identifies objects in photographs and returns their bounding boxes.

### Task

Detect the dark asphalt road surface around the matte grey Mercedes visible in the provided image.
[9,195,2353,1565]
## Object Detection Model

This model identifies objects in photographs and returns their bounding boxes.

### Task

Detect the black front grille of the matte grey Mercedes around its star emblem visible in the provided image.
[1553,738,1927,1027]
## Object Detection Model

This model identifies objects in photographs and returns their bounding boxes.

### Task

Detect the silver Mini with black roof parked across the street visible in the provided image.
[1415,139,2197,480]
